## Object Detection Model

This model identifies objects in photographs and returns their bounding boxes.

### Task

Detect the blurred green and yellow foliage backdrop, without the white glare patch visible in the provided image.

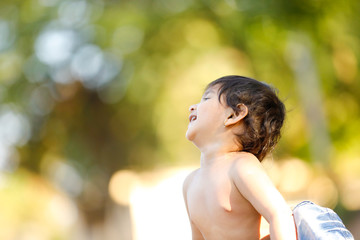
[0,0,360,240]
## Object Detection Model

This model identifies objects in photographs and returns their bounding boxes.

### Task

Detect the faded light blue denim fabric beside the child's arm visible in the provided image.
[293,201,354,240]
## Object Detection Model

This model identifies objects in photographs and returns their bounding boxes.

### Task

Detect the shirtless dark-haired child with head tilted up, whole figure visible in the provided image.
[183,76,296,240]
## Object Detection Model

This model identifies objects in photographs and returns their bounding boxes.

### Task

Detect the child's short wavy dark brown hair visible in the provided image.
[207,75,285,161]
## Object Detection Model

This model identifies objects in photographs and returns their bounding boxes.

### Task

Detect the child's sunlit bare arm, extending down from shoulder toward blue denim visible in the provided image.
[230,156,296,240]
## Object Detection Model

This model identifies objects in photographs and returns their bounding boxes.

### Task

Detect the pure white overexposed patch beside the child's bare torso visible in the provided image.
[131,169,191,240]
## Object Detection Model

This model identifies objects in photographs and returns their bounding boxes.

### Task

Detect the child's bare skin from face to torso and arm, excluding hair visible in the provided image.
[183,86,296,240]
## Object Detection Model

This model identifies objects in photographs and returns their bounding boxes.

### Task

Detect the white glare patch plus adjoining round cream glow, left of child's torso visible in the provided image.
[109,168,193,240]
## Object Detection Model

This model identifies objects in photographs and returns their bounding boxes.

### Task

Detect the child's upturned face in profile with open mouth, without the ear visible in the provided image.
[186,86,229,142]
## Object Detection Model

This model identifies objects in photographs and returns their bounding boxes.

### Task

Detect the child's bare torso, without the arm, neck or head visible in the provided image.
[184,157,261,240]
